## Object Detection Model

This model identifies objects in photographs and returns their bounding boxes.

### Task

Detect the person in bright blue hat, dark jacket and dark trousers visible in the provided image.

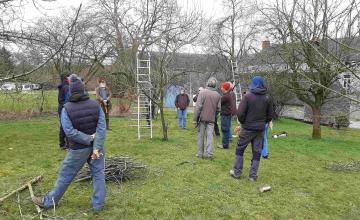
[230,76,273,181]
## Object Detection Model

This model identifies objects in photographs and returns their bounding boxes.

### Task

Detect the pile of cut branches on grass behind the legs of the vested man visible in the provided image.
[75,156,147,184]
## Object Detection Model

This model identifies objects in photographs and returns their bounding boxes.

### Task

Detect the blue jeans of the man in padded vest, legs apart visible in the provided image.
[44,148,106,210]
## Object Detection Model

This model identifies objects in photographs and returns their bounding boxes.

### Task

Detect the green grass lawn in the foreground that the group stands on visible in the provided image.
[0,111,360,219]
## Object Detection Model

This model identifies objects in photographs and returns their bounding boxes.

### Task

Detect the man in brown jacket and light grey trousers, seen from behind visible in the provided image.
[194,77,221,160]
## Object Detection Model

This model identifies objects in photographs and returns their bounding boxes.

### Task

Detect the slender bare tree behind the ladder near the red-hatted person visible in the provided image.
[206,0,258,80]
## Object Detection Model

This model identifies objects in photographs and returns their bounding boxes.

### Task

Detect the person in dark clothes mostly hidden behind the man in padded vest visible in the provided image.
[58,73,70,150]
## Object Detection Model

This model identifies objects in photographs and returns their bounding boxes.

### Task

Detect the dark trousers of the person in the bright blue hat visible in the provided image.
[234,128,264,179]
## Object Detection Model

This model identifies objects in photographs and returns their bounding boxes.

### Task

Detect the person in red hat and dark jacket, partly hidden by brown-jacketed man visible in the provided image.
[219,82,234,149]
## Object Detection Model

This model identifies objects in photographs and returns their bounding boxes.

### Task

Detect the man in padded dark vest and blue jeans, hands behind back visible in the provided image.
[31,74,106,211]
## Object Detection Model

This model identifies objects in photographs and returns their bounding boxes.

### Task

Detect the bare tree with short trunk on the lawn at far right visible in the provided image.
[260,0,360,139]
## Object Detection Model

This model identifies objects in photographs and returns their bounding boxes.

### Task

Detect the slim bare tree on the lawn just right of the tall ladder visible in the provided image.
[148,0,204,140]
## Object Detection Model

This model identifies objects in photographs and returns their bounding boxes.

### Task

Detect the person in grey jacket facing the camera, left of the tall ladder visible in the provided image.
[95,78,111,130]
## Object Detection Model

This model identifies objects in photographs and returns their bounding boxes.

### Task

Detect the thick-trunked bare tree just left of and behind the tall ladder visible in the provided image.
[93,0,179,96]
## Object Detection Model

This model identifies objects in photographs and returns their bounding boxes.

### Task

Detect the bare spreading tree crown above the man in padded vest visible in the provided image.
[23,7,113,82]
